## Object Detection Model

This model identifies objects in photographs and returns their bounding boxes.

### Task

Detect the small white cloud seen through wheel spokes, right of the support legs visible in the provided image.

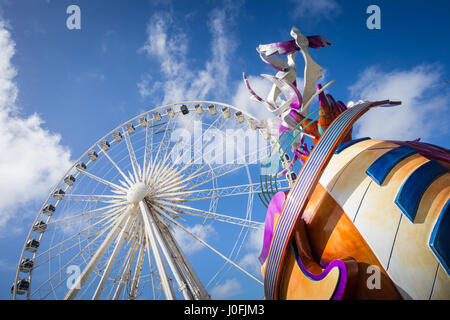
[175,224,216,255]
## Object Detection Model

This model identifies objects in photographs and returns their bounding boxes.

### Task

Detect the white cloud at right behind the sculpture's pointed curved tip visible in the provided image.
[349,65,450,140]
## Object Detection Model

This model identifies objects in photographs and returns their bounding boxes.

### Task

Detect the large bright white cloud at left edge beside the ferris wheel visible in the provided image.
[0,20,71,227]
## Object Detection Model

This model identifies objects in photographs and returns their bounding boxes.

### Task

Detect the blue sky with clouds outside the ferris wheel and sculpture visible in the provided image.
[0,0,450,299]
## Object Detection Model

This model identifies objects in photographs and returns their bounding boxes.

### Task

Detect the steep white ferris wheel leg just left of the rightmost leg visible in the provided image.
[139,201,175,300]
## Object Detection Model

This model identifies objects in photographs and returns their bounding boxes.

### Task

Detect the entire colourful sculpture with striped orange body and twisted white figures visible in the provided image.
[244,27,450,299]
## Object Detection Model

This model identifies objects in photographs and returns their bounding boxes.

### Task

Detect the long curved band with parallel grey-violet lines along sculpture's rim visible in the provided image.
[264,103,370,299]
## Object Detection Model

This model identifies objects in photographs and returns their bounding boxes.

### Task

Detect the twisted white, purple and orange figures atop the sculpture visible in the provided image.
[243,27,340,177]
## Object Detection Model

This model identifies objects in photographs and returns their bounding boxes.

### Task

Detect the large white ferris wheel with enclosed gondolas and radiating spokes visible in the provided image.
[11,101,289,299]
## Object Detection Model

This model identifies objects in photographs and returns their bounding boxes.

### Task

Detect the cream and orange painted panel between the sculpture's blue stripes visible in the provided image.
[320,140,450,299]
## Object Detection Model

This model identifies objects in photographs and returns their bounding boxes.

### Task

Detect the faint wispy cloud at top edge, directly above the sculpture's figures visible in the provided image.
[291,0,341,19]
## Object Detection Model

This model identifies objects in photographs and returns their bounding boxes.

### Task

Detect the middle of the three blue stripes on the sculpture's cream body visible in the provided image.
[395,160,447,222]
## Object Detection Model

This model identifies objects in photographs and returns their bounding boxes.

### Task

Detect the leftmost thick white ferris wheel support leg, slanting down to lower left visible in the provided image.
[64,205,137,300]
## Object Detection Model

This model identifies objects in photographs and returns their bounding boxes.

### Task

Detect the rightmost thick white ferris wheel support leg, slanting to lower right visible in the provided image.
[139,201,192,300]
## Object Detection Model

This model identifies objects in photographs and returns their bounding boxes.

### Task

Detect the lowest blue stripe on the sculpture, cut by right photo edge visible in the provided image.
[429,199,450,275]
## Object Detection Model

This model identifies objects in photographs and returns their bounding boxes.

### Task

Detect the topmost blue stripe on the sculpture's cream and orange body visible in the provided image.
[366,145,417,186]
